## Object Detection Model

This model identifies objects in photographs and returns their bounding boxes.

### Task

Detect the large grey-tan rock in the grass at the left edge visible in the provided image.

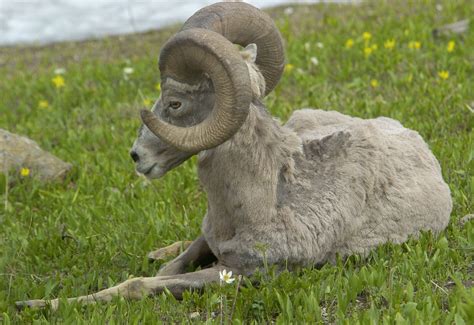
[0,129,72,181]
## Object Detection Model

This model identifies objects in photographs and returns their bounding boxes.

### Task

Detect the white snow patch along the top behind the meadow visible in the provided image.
[0,0,354,45]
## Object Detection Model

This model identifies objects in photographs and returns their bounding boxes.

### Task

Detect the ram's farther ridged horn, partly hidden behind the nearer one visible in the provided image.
[182,2,285,96]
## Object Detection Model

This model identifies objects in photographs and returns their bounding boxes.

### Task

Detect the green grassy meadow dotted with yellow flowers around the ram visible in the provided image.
[0,0,474,324]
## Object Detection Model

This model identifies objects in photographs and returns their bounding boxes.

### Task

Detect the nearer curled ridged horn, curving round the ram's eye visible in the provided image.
[141,28,252,152]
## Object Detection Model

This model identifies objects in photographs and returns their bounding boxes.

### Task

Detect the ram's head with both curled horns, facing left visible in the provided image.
[130,3,284,178]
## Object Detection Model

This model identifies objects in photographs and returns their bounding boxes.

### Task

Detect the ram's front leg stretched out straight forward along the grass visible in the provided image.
[16,265,239,310]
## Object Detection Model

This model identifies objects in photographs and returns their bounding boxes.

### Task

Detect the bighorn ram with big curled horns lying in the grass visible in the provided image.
[18,3,452,308]
